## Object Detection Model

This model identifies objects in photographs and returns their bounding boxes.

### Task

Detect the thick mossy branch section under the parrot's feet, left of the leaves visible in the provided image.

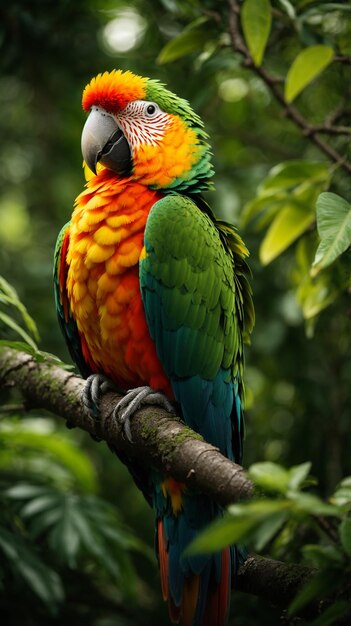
[0,349,253,506]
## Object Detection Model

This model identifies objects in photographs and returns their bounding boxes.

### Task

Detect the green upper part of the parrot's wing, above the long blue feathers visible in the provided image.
[140,195,254,380]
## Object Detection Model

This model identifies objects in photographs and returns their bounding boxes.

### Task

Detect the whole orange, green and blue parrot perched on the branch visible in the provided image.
[54,70,254,626]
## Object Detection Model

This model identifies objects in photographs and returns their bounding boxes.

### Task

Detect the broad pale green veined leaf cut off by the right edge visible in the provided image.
[311,192,351,276]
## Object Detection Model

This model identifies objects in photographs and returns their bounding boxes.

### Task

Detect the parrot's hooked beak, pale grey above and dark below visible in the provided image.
[82,107,131,175]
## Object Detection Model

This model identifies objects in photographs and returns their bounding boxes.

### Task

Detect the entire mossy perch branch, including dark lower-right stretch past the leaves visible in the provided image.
[0,348,328,614]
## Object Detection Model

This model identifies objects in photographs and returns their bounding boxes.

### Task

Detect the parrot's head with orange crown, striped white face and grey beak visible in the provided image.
[82,70,213,192]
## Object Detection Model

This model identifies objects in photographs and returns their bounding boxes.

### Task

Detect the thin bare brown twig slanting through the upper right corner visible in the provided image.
[228,0,351,174]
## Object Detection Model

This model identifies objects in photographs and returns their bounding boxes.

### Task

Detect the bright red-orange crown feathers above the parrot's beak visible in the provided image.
[82,70,147,113]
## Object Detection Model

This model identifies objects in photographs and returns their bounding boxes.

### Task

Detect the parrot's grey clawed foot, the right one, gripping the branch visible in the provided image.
[113,386,175,443]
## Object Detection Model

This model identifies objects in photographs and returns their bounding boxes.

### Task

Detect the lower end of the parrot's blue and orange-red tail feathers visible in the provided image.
[157,519,235,626]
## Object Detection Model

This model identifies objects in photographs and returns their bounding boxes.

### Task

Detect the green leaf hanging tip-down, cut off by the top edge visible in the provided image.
[240,0,272,66]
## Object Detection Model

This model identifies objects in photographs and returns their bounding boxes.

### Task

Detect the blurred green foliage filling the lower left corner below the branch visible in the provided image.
[0,418,151,620]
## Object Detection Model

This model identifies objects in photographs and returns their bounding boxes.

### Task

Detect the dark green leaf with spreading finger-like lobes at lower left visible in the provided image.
[4,483,146,595]
